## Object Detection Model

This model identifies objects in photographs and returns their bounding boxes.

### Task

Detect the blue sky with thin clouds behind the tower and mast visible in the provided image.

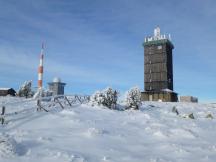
[0,0,216,102]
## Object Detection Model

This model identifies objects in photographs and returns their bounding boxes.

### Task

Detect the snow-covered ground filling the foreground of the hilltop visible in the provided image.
[0,97,216,162]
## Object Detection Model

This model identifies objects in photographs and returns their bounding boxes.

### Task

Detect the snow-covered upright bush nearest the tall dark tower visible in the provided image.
[126,87,141,109]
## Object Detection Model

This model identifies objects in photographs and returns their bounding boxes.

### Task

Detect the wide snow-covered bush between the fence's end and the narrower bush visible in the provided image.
[90,87,118,109]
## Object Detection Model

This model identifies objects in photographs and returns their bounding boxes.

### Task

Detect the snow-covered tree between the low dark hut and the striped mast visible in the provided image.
[17,80,33,98]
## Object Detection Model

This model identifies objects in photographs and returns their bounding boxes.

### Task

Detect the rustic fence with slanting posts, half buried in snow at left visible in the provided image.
[0,95,90,125]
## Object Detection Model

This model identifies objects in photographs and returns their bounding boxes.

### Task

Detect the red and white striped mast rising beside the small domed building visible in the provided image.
[38,43,44,90]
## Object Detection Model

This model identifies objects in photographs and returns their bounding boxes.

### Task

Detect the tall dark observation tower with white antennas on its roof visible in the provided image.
[142,27,178,102]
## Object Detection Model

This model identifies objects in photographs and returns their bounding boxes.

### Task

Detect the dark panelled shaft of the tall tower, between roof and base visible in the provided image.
[144,43,173,91]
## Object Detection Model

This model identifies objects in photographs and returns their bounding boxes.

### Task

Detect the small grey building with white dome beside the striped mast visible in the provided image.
[48,77,66,96]
